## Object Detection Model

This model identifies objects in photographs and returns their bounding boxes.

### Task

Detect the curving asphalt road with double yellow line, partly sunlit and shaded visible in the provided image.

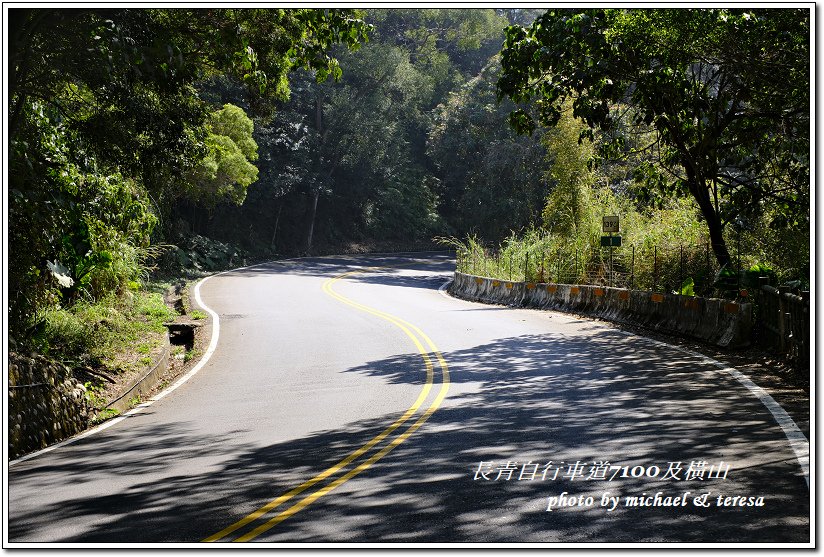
[7,254,810,544]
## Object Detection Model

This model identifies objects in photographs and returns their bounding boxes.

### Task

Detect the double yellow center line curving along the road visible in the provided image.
[203,267,449,542]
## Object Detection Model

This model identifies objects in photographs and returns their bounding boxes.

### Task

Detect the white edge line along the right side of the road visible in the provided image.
[438,279,810,489]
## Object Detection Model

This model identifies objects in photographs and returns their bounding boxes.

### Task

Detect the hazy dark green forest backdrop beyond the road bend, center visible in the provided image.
[196,9,516,253]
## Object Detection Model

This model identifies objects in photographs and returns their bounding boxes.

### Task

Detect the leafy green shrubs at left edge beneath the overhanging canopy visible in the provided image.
[9,103,157,333]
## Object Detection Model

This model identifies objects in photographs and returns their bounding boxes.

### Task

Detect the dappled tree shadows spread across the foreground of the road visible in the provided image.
[4,329,809,543]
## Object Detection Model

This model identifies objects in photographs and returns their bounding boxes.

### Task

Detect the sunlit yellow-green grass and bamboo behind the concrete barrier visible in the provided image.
[441,97,810,298]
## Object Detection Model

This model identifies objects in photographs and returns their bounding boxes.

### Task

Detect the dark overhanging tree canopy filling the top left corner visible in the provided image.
[8,8,367,204]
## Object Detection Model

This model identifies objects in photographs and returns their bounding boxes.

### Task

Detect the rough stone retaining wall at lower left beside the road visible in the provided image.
[7,352,92,459]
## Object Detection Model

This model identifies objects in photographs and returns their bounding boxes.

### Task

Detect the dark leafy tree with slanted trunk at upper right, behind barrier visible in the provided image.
[498,8,810,265]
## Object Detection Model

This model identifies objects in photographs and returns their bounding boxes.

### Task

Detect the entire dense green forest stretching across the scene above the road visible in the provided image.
[7,8,810,364]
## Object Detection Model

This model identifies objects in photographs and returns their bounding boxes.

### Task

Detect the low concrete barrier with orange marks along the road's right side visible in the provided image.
[449,272,752,347]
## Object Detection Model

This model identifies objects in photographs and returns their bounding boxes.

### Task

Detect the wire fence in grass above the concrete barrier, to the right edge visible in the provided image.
[456,239,811,373]
